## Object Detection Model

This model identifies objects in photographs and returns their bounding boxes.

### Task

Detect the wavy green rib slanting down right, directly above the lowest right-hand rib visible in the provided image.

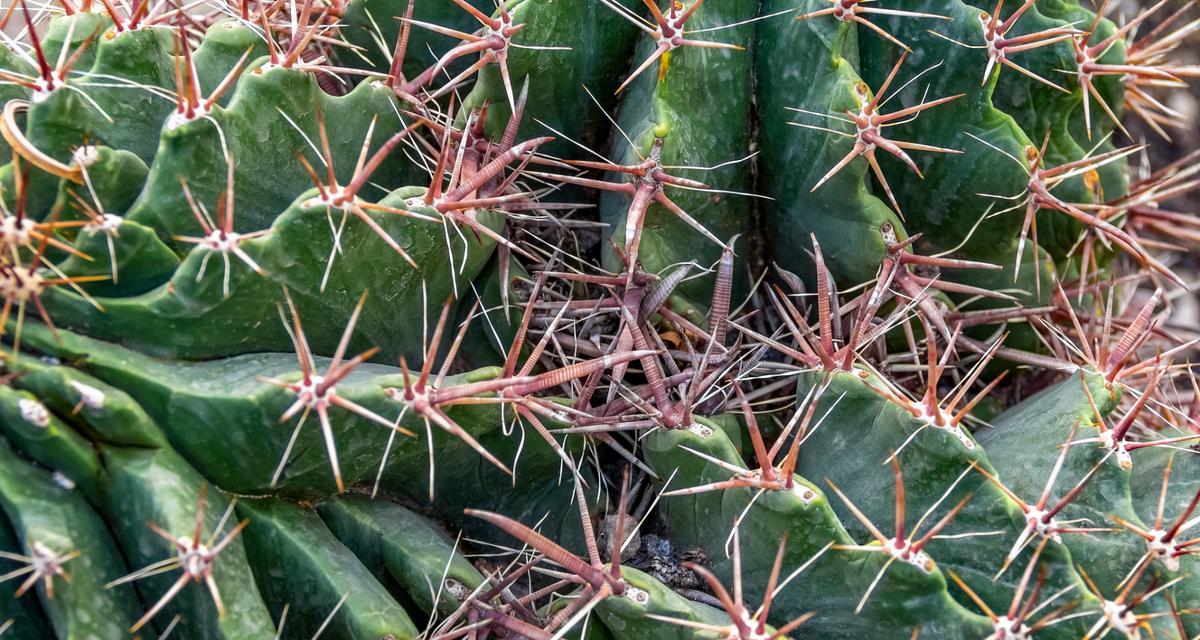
[798,373,1094,633]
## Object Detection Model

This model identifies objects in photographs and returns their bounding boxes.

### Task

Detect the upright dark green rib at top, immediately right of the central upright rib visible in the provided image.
[756,2,904,282]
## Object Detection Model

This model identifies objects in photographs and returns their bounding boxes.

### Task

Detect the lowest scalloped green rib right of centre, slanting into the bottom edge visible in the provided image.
[643,420,998,638]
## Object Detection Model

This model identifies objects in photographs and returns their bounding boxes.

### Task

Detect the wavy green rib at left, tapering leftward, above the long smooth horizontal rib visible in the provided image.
[46,187,500,359]
